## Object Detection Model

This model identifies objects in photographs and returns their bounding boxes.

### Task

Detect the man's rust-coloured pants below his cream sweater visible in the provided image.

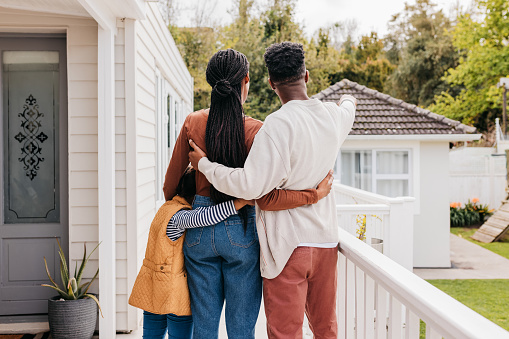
[263,247,338,339]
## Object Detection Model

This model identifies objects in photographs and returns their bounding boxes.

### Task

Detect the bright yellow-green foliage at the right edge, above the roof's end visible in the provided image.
[429,0,509,131]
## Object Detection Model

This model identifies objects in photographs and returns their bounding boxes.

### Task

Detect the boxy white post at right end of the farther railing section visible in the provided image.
[383,197,415,271]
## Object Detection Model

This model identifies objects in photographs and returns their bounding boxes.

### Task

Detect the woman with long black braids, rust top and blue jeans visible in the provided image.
[163,49,328,339]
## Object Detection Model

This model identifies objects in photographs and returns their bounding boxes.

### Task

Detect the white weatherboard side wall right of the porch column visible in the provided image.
[124,3,193,330]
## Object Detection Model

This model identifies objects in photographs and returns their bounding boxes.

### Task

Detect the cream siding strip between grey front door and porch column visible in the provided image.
[67,23,98,286]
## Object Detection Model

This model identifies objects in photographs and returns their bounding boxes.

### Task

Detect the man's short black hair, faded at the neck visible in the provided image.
[263,41,306,83]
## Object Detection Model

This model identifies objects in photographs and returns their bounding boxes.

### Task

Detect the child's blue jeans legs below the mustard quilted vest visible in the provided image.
[143,311,193,339]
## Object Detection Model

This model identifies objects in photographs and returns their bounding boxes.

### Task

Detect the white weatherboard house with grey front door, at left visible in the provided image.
[0,0,193,338]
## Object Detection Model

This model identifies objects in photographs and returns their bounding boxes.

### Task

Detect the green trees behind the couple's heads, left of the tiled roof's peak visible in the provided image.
[166,0,394,120]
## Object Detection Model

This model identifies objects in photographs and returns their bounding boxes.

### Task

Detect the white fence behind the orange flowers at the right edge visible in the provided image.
[449,147,507,208]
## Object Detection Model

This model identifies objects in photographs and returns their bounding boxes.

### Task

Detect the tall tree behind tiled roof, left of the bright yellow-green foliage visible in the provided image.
[386,0,458,106]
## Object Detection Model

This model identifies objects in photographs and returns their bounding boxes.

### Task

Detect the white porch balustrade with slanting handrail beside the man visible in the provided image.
[303,184,509,339]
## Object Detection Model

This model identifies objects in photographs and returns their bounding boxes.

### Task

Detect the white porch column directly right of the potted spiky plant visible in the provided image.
[97,26,116,339]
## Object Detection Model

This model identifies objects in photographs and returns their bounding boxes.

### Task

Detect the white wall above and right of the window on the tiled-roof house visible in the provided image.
[337,139,450,267]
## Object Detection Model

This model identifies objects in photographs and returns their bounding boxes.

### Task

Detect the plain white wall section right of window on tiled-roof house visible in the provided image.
[414,142,451,267]
